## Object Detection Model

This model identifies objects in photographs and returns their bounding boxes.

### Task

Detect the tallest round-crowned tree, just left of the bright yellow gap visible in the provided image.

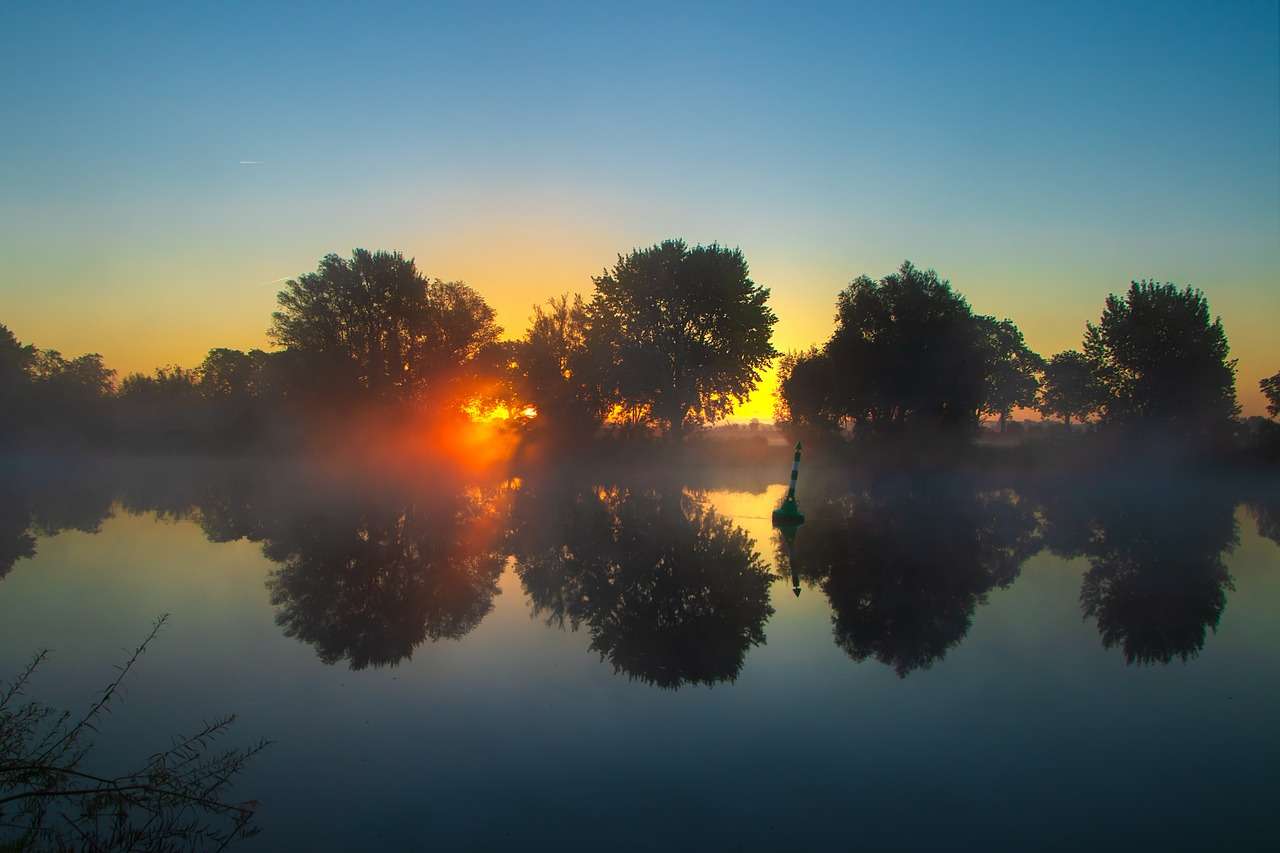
[586,240,777,432]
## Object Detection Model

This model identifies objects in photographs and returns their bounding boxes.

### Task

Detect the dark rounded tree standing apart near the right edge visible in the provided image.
[1084,280,1240,438]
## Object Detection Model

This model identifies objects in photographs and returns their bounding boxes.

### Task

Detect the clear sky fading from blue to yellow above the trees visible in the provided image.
[0,0,1280,419]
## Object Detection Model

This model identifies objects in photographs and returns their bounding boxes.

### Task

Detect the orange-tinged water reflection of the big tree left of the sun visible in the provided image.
[112,458,507,670]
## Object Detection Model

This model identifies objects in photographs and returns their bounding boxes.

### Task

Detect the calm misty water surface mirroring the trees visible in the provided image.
[0,452,1280,850]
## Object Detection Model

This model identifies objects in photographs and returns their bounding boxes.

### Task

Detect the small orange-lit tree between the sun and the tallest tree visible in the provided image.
[513,296,609,438]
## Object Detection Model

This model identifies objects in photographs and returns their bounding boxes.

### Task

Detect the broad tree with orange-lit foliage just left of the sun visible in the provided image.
[269,248,502,400]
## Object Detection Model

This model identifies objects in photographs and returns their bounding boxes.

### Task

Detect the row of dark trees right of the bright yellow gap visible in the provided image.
[777,263,1264,441]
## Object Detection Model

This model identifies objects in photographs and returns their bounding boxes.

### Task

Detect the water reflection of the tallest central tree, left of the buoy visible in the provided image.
[509,480,773,689]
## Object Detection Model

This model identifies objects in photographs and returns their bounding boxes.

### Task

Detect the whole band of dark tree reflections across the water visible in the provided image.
[0,460,1259,688]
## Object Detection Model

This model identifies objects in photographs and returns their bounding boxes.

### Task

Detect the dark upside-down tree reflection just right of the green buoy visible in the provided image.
[778,476,1038,678]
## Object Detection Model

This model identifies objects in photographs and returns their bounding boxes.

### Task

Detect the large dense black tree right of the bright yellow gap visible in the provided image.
[824,261,991,429]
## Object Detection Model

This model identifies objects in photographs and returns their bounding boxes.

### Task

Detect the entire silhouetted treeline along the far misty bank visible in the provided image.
[0,240,1280,450]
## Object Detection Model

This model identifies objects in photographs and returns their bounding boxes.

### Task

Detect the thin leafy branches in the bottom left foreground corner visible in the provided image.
[0,617,268,850]
